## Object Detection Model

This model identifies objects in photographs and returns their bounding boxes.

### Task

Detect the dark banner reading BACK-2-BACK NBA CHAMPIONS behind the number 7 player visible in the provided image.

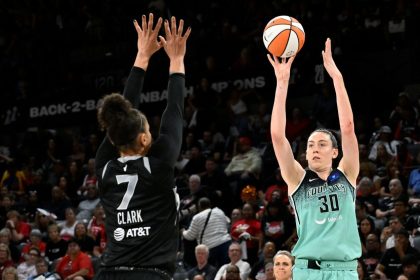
[0,76,266,129]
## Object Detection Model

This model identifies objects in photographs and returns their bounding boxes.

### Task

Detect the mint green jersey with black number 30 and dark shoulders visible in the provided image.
[289,169,361,261]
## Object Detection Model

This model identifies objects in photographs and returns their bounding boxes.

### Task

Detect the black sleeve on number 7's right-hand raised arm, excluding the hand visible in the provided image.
[150,73,185,166]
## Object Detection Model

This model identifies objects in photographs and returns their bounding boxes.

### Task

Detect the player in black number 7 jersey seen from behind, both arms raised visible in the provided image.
[96,14,191,280]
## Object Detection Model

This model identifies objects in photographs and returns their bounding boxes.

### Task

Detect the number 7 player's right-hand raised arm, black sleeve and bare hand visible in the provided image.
[150,17,191,165]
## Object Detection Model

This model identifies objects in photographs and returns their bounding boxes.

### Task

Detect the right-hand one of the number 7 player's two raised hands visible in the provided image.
[159,17,191,61]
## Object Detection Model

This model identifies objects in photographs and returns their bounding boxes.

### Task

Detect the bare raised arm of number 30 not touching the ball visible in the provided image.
[322,38,359,186]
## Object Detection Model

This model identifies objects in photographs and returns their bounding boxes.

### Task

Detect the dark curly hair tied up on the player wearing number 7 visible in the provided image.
[98,93,147,149]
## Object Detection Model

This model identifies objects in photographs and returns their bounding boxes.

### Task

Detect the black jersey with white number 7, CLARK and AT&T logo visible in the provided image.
[98,156,179,271]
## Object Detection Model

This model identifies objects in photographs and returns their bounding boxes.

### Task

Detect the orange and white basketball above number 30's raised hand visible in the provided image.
[263,16,305,58]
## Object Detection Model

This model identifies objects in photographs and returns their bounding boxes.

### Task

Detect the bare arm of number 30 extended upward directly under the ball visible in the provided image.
[267,55,305,194]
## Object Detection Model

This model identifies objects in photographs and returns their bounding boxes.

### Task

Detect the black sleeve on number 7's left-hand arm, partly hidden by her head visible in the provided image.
[95,66,146,170]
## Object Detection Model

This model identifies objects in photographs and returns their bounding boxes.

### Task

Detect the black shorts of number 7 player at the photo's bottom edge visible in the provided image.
[93,267,172,280]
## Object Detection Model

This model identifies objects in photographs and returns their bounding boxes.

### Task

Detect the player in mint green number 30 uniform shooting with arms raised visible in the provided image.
[268,39,361,280]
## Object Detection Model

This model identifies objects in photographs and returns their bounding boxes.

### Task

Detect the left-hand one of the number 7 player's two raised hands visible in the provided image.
[134,13,162,59]
